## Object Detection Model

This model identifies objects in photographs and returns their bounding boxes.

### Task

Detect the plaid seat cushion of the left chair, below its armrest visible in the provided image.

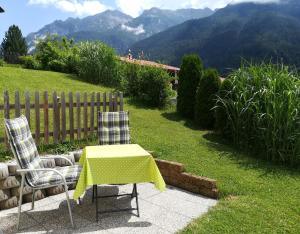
[33,165,81,186]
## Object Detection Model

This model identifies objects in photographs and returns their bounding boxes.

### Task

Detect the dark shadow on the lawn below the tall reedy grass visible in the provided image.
[203,132,300,177]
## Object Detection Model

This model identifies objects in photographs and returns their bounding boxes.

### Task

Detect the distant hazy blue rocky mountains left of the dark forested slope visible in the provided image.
[26,8,213,53]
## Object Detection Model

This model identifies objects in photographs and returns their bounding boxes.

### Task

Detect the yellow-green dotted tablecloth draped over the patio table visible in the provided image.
[73,144,166,200]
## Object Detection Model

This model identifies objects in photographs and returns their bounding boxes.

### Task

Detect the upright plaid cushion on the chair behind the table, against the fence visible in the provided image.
[98,111,130,145]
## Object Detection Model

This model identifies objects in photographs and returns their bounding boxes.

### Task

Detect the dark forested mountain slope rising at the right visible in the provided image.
[131,1,300,73]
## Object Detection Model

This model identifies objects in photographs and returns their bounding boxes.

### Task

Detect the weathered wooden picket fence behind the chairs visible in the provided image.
[0,91,123,144]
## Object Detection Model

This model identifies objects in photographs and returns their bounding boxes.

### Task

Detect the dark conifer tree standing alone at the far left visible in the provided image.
[1,25,27,63]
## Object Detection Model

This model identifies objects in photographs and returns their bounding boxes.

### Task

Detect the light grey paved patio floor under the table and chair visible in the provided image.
[0,183,217,234]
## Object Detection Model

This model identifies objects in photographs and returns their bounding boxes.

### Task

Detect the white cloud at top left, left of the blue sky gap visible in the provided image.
[28,0,109,16]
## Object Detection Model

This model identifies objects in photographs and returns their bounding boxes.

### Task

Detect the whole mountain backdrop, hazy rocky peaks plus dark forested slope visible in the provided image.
[27,0,300,75]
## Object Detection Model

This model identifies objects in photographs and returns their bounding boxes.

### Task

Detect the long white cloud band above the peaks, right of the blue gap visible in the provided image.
[116,0,280,17]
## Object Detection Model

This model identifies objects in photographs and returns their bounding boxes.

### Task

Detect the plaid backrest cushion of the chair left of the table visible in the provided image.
[5,116,44,184]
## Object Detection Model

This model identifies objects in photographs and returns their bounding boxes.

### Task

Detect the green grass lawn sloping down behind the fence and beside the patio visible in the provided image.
[0,68,300,233]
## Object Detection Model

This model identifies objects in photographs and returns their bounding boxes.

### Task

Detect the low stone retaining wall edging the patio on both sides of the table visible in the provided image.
[0,151,218,210]
